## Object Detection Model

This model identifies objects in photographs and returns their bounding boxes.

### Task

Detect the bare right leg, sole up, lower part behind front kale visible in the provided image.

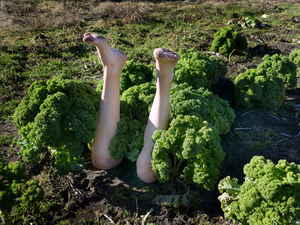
[136,48,180,183]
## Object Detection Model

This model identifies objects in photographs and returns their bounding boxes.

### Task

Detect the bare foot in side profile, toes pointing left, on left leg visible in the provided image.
[83,33,127,74]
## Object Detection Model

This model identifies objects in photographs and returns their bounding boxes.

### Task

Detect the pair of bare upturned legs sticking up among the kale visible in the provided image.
[83,33,180,183]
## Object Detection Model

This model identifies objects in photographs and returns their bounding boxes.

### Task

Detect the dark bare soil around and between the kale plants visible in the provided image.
[0,0,300,224]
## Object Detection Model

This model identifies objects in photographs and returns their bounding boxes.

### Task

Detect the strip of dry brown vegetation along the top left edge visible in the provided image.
[0,0,150,31]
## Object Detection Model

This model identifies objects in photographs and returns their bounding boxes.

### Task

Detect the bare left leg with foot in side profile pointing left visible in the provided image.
[83,33,127,170]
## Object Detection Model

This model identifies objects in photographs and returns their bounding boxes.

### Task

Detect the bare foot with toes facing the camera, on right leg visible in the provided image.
[153,48,180,81]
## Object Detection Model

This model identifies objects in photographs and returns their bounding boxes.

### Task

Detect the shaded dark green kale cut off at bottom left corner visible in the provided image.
[0,158,44,224]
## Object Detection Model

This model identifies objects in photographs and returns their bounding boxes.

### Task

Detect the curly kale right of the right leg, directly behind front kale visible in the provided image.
[170,85,235,134]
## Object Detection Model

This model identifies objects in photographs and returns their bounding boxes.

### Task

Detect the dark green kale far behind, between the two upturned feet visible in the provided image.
[97,59,154,94]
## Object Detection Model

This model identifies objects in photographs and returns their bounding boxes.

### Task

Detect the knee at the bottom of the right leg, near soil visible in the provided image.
[136,157,157,183]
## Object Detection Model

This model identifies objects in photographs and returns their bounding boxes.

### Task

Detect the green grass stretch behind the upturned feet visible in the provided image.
[0,1,292,84]
